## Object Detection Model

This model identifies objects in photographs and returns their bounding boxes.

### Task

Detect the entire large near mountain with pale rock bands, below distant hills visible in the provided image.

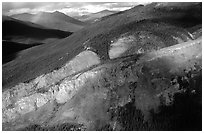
[2,3,202,131]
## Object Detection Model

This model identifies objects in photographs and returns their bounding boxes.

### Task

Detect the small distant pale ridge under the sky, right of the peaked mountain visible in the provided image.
[75,10,117,23]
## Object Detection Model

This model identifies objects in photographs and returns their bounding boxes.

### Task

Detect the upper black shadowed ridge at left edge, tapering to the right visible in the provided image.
[2,16,71,45]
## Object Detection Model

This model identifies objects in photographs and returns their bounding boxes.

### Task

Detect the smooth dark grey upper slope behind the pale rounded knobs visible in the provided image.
[2,3,202,89]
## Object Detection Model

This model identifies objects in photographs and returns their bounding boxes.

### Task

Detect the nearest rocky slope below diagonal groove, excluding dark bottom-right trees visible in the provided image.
[3,39,202,130]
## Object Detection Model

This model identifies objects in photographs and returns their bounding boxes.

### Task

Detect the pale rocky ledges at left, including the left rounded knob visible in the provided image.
[3,51,100,122]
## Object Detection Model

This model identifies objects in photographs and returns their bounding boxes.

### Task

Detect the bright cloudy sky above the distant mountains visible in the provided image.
[2,2,148,16]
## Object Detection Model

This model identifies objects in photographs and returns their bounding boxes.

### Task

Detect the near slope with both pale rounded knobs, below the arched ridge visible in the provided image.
[3,2,202,130]
